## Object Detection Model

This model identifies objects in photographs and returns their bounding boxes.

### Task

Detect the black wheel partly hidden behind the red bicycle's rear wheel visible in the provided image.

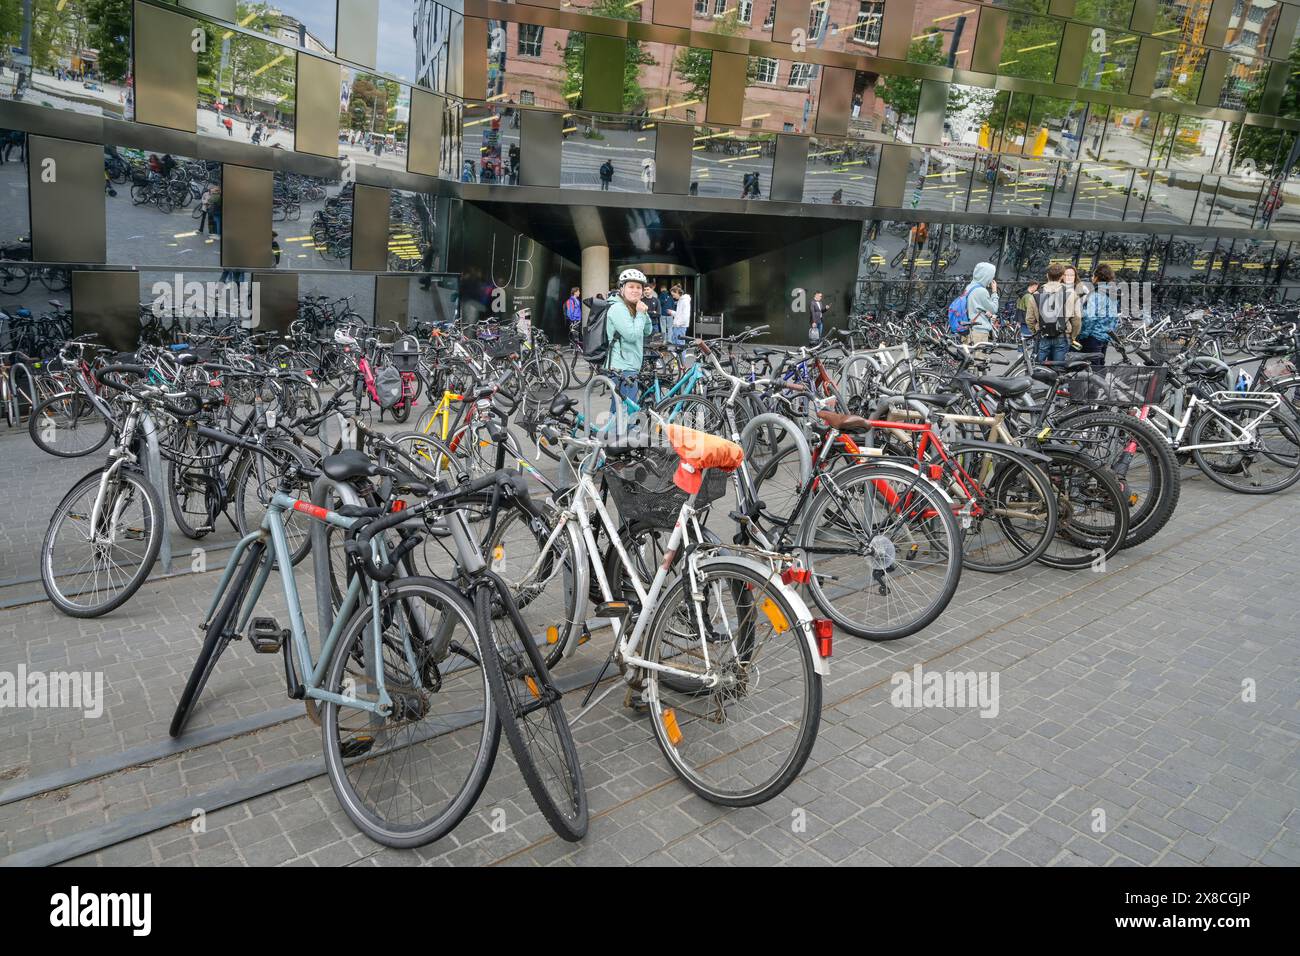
[1039,446,1128,570]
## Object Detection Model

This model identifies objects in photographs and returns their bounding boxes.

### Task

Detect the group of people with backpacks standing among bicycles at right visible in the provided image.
[962,263,1119,367]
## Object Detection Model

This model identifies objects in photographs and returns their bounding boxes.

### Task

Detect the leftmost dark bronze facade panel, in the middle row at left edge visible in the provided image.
[27,137,108,263]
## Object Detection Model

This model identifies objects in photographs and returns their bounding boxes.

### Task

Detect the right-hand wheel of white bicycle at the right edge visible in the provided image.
[1187,401,1300,494]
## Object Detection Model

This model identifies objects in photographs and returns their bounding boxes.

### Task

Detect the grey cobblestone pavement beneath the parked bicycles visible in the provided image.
[0,418,1300,866]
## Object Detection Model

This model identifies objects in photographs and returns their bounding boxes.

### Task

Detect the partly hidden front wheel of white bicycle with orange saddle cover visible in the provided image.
[478,496,589,669]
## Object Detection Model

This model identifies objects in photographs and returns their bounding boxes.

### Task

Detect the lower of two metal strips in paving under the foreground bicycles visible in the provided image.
[0,666,613,866]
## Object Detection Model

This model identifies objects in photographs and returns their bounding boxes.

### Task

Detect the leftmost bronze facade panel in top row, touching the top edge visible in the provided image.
[133,3,199,133]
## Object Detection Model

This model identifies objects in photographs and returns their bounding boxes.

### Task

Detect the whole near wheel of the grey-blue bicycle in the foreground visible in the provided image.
[320,578,501,848]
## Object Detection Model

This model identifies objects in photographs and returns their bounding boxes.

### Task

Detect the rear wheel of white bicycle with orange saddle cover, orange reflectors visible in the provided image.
[645,557,822,806]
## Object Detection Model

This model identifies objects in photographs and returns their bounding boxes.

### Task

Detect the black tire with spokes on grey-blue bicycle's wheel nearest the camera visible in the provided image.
[320,576,501,849]
